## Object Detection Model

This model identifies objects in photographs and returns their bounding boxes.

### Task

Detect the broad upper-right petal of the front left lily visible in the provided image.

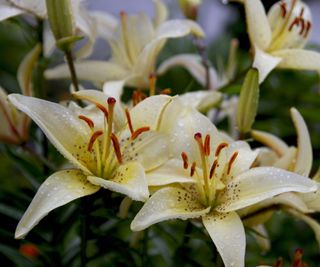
[130,95,172,130]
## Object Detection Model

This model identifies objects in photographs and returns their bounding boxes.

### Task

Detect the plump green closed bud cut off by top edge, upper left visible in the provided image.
[46,0,80,51]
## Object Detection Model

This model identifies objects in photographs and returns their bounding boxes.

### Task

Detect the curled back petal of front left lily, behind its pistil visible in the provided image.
[73,90,126,131]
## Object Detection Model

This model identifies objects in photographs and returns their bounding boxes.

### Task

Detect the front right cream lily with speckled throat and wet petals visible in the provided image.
[131,100,317,267]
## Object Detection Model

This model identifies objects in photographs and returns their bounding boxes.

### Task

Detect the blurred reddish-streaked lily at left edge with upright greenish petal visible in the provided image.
[0,45,41,145]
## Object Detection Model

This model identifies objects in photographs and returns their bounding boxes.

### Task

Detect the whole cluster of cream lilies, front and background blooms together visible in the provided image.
[0,0,320,267]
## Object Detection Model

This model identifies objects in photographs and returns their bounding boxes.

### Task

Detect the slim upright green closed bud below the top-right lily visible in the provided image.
[237,69,259,134]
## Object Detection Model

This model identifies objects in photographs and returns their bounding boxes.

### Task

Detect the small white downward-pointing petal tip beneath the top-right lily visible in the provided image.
[252,46,282,83]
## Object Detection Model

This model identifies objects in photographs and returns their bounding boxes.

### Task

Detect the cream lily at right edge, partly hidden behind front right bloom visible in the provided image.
[245,108,320,249]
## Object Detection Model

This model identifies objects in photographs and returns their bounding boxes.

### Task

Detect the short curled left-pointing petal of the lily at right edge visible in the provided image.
[251,130,289,157]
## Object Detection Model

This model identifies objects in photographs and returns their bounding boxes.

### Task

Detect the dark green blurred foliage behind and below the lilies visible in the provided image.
[0,0,320,267]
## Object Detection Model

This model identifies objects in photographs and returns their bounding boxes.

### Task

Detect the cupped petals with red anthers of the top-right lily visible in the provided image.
[268,0,312,50]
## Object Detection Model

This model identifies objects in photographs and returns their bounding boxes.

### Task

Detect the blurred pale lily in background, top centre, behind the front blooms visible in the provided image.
[46,0,204,90]
